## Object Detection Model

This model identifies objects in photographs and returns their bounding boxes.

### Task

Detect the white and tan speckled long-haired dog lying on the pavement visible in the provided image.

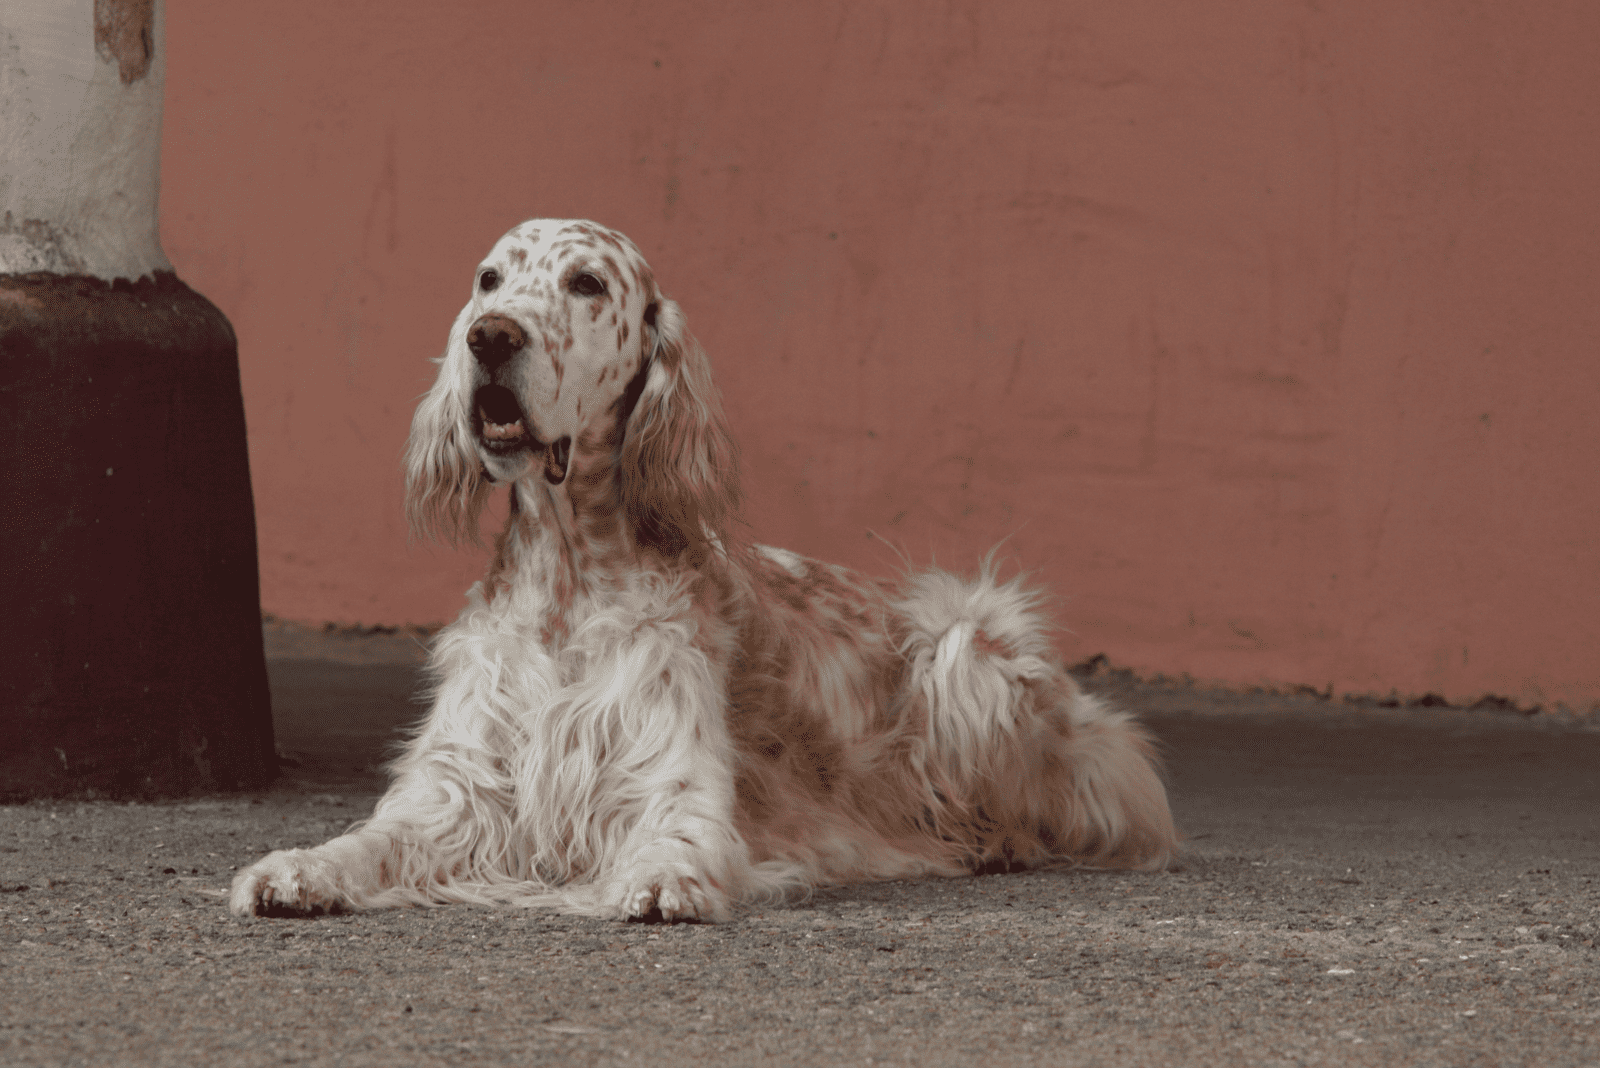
[230,219,1176,921]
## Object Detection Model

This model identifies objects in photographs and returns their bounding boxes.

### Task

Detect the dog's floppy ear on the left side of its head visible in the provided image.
[405,350,491,545]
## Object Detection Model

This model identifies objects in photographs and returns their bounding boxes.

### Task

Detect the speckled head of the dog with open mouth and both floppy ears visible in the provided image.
[406,219,738,553]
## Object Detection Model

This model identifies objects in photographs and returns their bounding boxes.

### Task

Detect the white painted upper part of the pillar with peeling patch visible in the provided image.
[0,0,173,280]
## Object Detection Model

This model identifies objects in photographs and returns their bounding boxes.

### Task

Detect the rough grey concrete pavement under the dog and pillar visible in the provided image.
[0,633,1600,1068]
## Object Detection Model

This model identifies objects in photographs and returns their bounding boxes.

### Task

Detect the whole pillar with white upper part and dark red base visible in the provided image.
[0,0,274,798]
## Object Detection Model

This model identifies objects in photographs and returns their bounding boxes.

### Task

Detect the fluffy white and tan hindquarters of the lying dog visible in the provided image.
[898,566,1178,868]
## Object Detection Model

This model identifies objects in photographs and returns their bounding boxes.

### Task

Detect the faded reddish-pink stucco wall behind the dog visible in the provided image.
[162,0,1600,708]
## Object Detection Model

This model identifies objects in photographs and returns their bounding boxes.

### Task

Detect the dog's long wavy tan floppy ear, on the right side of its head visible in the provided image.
[621,296,739,558]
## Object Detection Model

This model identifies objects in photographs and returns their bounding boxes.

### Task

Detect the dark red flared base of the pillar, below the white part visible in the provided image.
[0,273,275,798]
